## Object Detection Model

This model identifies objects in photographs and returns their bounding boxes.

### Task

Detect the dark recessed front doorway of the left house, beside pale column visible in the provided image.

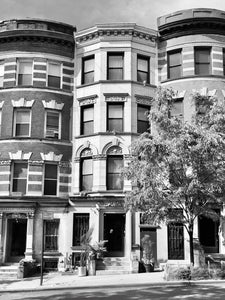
[7,219,27,262]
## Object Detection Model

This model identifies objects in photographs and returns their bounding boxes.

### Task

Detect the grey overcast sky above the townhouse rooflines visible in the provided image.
[0,0,225,30]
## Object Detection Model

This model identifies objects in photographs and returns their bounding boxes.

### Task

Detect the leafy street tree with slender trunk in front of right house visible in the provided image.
[124,88,225,264]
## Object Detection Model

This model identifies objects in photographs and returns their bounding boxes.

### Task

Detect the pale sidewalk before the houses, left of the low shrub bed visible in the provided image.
[0,272,166,292]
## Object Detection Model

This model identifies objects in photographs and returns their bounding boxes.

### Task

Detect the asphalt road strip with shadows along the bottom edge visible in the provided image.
[0,283,225,300]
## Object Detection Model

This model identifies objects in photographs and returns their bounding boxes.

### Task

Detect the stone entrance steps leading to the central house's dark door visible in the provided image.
[96,257,131,275]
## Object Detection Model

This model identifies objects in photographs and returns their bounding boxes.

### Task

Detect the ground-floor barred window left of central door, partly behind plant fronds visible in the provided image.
[73,214,89,246]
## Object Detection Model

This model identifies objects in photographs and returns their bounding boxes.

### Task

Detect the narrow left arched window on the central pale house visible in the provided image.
[80,148,93,191]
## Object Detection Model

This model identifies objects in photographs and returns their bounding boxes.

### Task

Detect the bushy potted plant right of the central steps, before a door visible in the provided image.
[141,234,155,272]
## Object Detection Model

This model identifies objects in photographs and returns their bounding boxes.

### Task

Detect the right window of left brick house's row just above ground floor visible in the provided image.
[44,164,58,196]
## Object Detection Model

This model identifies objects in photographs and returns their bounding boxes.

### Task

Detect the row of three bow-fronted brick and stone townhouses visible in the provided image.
[0,9,225,272]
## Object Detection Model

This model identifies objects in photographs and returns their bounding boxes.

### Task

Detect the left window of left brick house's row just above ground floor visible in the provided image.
[12,162,27,194]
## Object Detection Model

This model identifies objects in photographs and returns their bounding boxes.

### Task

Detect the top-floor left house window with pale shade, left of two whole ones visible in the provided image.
[17,59,33,86]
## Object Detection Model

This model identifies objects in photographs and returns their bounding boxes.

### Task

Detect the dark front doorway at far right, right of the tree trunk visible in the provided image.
[198,216,219,253]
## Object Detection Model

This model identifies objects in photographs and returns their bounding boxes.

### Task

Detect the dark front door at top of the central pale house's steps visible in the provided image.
[104,214,125,256]
